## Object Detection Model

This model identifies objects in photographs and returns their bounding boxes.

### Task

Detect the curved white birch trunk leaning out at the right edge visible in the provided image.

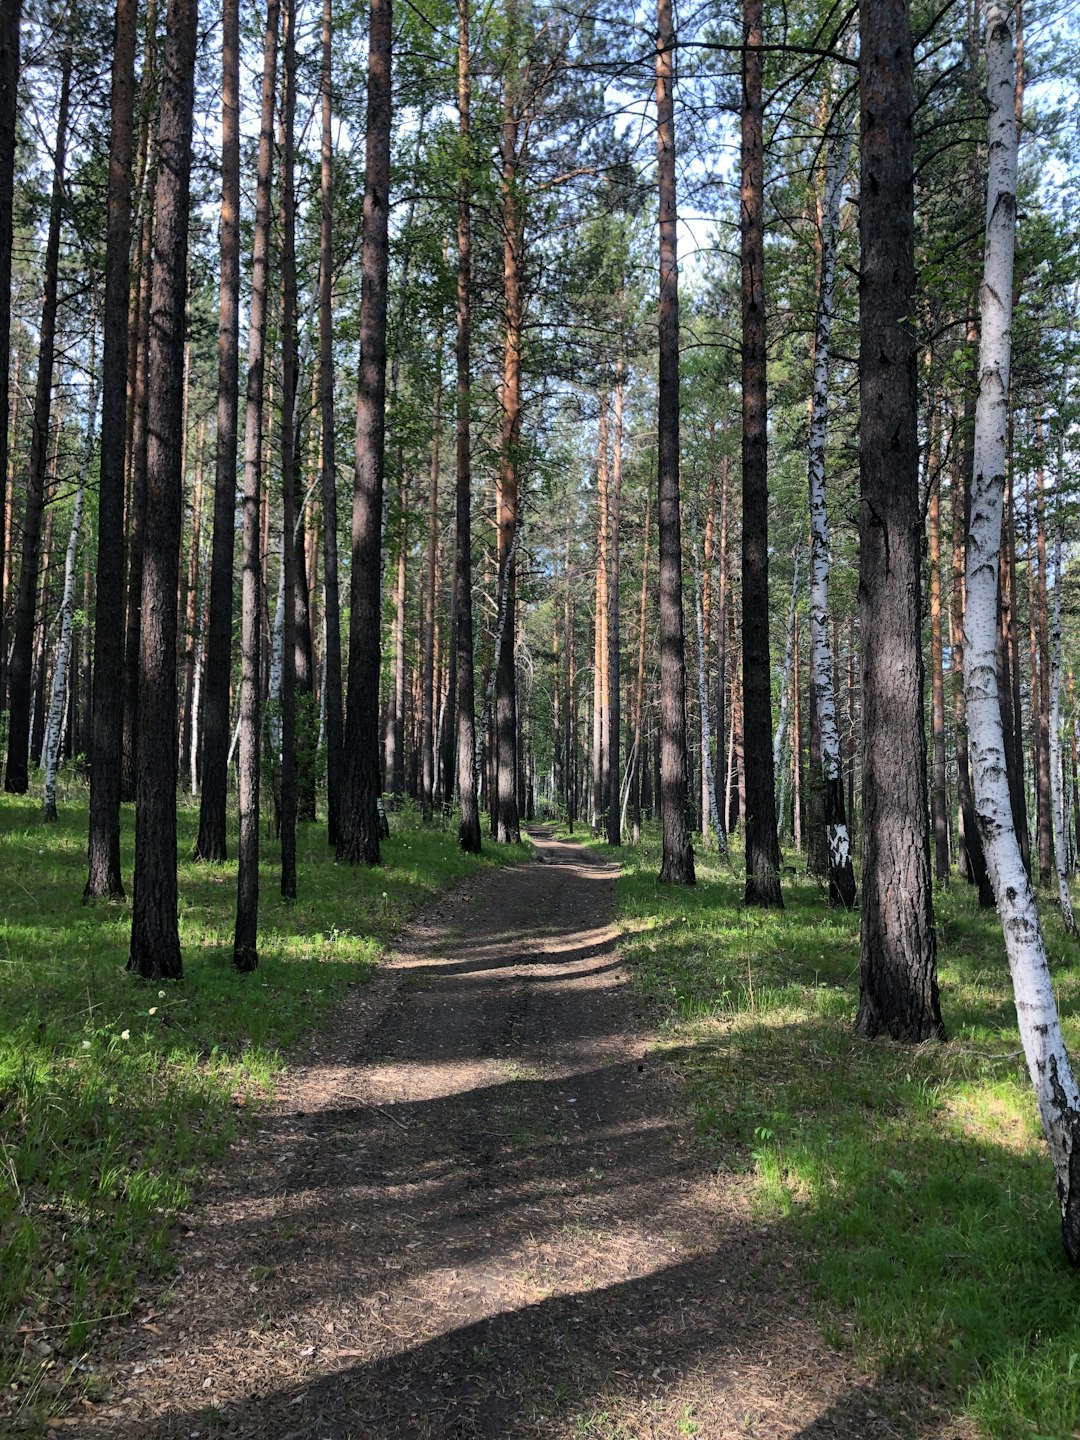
[963,0,1080,1264]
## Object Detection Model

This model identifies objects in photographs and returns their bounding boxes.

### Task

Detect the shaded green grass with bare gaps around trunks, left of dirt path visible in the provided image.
[0,793,527,1430]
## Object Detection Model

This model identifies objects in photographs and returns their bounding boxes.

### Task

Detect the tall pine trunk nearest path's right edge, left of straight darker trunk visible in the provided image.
[657,0,694,886]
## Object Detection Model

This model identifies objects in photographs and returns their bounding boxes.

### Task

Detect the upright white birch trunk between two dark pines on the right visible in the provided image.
[806,106,855,909]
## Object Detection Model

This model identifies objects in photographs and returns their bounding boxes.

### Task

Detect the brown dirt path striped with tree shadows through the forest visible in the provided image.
[86,838,960,1440]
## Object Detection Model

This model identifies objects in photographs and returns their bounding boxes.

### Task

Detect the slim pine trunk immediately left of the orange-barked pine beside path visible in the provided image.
[454,0,480,855]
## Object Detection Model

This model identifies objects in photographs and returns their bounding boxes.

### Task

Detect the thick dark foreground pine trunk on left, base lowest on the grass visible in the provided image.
[128,0,199,979]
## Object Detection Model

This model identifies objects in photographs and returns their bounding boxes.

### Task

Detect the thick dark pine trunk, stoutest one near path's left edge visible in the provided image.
[337,0,393,865]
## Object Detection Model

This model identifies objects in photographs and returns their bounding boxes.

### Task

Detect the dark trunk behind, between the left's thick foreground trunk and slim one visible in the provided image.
[194,0,240,861]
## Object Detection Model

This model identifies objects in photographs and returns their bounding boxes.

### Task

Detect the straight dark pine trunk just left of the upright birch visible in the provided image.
[740,0,783,906]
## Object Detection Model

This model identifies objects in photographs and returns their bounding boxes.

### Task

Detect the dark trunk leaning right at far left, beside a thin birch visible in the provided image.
[3,43,72,795]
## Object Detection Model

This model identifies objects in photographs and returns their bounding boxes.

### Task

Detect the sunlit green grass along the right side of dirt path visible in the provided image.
[619,838,1080,1440]
